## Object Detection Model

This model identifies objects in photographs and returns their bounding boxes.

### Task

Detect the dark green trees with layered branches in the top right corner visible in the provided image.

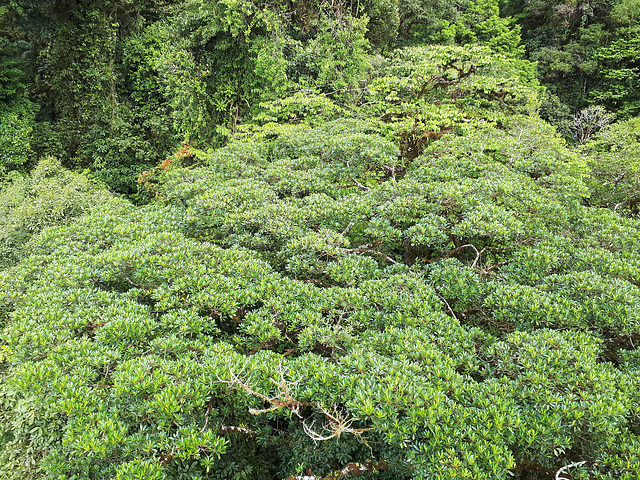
[505,0,640,122]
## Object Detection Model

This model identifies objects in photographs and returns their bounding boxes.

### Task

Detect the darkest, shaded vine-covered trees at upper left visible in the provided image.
[17,1,176,194]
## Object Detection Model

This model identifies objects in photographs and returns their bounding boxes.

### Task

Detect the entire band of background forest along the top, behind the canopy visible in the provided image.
[0,0,640,188]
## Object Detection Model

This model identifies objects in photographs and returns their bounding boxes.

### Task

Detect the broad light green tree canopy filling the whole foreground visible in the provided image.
[0,48,640,480]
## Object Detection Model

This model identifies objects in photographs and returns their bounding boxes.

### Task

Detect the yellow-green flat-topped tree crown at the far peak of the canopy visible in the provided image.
[362,46,540,160]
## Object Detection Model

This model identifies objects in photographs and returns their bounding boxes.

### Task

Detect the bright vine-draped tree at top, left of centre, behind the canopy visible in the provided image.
[152,0,286,142]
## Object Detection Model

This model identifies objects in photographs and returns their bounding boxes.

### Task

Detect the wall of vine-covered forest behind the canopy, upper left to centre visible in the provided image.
[0,0,380,193]
